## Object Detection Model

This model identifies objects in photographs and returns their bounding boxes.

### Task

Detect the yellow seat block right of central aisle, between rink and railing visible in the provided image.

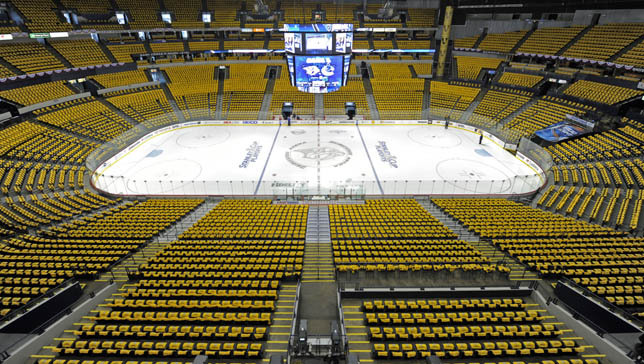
[329,200,508,273]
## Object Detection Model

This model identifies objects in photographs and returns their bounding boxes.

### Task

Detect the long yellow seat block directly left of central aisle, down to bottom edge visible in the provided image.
[40,200,307,360]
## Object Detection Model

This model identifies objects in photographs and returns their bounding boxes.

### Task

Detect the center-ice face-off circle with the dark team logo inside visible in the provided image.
[285,141,353,168]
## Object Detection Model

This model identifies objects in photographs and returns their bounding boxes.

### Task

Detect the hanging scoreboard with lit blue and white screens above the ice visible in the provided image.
[283,24,353,93]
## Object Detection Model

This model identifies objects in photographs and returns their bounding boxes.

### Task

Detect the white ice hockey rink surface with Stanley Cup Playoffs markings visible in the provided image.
[92,122,545,196]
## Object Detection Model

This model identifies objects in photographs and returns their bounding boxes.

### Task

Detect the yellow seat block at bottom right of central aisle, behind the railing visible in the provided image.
[360,297,591,362]
